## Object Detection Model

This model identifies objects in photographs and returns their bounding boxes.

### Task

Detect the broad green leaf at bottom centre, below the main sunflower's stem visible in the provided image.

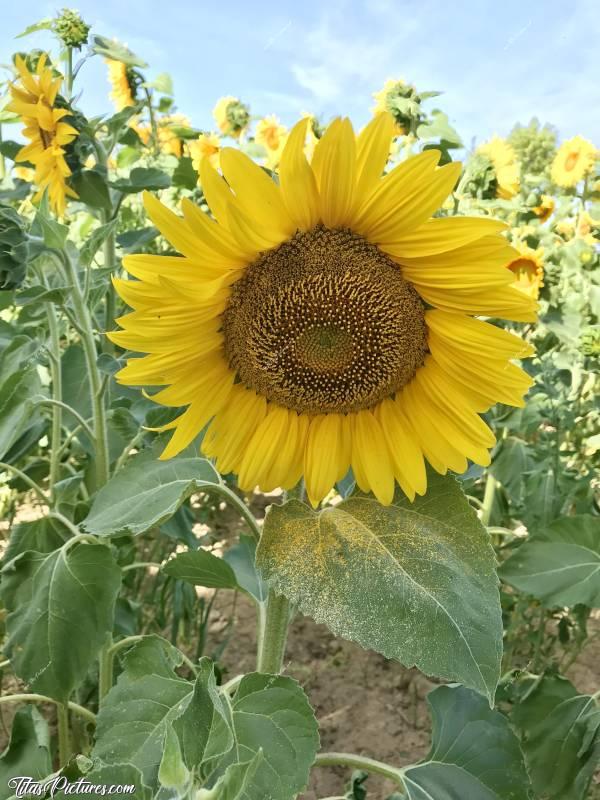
[209,672,319,800]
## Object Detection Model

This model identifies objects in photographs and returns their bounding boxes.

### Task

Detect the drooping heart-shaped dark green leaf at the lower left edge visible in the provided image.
[1,542,121,703]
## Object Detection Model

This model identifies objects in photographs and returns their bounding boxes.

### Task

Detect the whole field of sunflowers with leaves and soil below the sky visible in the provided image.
[0,9,600,800]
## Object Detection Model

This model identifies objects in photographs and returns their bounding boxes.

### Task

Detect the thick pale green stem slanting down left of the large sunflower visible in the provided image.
[62,253,109,489]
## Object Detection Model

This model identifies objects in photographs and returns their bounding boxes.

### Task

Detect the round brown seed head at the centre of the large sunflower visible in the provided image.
[223,226,427,414]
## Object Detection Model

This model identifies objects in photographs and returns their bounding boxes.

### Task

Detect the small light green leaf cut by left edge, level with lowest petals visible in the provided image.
[0,366,42,459]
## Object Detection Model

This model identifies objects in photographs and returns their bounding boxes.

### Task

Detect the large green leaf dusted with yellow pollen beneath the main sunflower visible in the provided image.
[258,473,502,699]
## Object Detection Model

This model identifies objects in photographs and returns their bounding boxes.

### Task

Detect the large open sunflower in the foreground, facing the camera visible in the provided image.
[108,113,536,505]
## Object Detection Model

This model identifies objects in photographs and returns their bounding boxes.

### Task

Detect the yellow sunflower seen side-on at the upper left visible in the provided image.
[7,54,78,216]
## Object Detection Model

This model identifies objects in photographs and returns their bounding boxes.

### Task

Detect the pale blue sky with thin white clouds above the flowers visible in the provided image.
[0,0,600,148]
